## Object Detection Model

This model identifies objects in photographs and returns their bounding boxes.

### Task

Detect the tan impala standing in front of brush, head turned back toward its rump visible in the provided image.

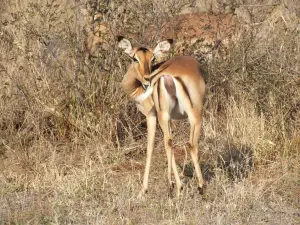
[118,37,205,196]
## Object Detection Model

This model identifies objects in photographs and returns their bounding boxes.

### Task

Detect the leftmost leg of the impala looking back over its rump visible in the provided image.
[138,114,156,198]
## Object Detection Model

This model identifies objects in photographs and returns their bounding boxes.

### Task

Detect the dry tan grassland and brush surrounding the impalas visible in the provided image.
[0,0,300,224]
